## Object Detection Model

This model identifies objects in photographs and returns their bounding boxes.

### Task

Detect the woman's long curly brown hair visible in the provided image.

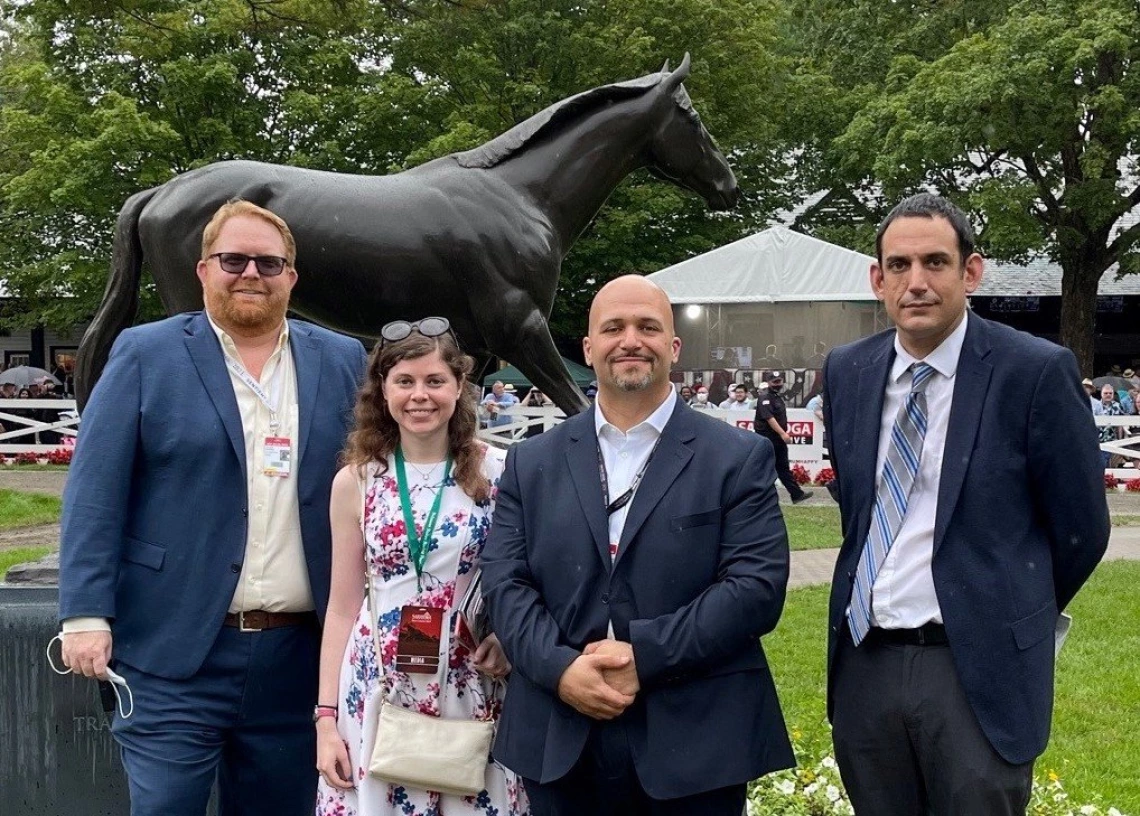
[341,332,491,501]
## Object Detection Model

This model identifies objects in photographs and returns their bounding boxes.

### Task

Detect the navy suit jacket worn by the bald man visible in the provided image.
[482,402,795,799]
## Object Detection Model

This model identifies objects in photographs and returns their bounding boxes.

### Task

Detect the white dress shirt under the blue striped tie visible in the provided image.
[871,315,968,629]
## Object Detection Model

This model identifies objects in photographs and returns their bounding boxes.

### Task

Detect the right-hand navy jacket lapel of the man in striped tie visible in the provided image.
[934,312,993,552]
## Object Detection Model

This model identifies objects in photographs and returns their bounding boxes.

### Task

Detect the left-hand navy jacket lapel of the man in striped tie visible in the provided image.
[848,334,895,546]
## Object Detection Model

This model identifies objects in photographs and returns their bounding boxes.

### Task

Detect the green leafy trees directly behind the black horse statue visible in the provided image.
[0,0,798,343]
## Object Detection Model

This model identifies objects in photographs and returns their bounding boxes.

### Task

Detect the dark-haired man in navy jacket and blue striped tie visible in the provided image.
[824,194,1108,816]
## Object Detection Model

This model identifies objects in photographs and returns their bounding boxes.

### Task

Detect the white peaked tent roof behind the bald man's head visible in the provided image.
[648,227,874,303]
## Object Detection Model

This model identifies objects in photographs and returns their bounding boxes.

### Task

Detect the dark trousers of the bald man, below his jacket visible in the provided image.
[523,719,747,816]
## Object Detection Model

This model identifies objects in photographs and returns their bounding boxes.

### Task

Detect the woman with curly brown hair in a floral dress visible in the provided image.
[316,318,528,816]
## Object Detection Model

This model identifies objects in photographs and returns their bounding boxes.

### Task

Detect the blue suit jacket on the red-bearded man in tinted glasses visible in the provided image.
[59,312,365,678]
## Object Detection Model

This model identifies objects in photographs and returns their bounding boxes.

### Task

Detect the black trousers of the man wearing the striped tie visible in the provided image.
[832,627,1033,816]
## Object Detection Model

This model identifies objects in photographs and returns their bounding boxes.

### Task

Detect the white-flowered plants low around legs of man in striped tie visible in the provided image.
[748,731,1125,816]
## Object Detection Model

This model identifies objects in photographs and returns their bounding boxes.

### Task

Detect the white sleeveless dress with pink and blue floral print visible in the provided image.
[316,447,528,816]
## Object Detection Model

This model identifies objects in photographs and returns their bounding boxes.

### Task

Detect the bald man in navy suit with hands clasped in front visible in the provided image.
[483,276,793,816]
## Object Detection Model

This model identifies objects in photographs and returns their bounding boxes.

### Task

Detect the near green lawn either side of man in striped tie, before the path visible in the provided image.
[764,565,1140,815]
